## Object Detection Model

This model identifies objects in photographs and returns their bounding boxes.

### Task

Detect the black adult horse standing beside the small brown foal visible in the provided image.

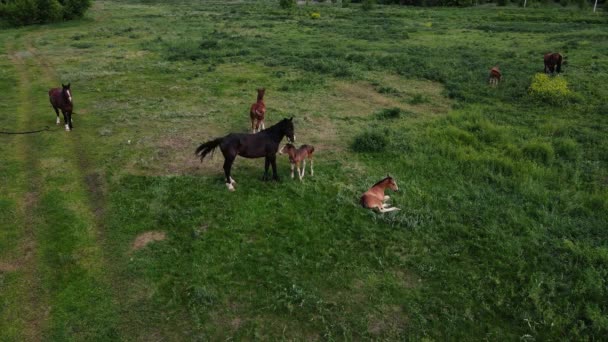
[196,118,296,191]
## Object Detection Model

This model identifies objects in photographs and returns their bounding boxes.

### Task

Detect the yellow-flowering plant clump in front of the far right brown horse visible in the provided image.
[528,73,574,105]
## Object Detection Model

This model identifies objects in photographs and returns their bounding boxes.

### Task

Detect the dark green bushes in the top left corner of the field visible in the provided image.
[0,0,91,26]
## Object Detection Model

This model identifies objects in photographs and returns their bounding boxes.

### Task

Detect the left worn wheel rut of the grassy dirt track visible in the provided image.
[0,38,49,341]
